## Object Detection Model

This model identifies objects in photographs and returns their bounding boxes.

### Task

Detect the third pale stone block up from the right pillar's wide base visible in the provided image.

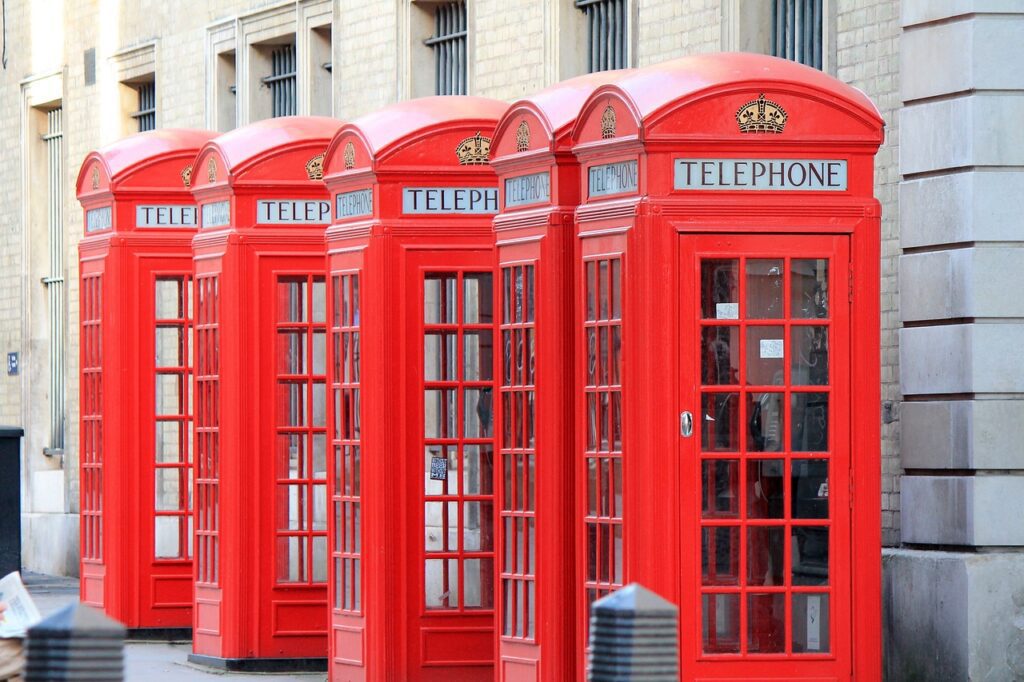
[899,323,1024,395]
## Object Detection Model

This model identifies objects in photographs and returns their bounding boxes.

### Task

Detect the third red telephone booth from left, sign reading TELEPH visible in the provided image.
[326,96,507,682]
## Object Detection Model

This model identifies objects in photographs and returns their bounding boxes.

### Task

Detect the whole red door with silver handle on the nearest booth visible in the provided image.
[679,235,852,679]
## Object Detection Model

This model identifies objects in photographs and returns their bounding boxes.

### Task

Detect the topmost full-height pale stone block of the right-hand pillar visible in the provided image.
[899,14,1024,101]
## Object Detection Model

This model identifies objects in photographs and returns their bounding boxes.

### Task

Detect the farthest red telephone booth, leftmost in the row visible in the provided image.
[77,129,214,637]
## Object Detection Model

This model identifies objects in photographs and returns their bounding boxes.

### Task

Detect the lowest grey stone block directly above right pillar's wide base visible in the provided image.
[900,475,1024,540]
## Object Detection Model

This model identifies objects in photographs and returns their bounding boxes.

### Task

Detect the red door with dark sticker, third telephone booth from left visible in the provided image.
[408,249,496,682]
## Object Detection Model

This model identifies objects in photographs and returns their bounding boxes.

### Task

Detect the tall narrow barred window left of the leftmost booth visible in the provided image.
[43,108,67,453]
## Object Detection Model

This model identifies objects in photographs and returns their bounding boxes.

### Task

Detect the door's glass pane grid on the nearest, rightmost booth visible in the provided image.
[699,253,833,657]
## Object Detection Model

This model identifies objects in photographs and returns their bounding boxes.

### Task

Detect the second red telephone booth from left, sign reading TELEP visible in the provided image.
[191,117,341,670]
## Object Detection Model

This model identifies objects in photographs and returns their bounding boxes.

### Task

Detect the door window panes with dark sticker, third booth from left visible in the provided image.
[423,272,495,611]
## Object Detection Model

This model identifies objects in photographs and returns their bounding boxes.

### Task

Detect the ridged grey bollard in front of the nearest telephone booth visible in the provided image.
[587,583,679,682]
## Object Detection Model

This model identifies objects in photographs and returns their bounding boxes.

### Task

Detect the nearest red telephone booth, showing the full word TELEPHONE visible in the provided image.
[572,54,883,680]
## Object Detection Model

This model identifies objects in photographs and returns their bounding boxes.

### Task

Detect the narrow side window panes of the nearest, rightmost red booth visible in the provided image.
[584,257,626,630]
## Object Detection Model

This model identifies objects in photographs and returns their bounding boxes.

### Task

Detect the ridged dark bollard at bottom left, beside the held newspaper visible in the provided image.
[25,603,125,682]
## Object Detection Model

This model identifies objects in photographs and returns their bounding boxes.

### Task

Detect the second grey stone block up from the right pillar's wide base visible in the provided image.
[899,399,1024,470]
